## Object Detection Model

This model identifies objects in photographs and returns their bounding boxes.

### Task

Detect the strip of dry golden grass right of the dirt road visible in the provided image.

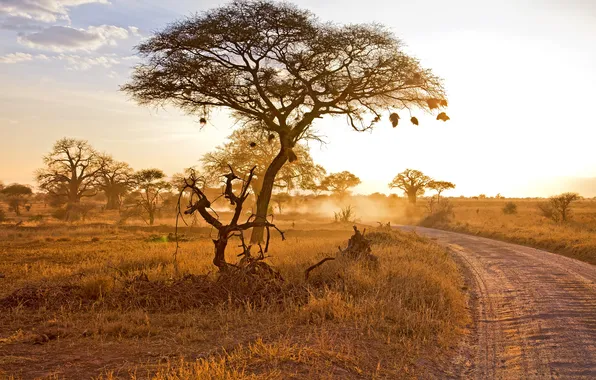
[428,199,596,264]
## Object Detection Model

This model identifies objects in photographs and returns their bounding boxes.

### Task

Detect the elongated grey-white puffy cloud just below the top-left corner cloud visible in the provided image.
[17,24,132,53]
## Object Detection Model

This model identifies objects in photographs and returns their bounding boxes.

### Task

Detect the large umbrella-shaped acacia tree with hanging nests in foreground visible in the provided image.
[123,1,447,242]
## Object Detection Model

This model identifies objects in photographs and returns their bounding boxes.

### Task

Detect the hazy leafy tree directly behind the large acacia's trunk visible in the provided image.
[201,127,324,197]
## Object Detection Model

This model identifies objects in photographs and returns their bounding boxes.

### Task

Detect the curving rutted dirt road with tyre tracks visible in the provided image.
[403,227,596,379]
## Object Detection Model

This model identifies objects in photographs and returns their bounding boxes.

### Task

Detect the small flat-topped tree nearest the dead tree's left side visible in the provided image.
[133,169,171,226]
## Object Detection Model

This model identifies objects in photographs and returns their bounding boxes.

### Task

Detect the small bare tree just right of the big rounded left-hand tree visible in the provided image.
[98,156,133,210]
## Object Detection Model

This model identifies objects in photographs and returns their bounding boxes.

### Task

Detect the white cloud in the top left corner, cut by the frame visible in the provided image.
[0,0,110,22]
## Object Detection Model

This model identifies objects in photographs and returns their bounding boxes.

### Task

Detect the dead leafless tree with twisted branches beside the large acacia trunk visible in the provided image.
[181,167,285,270]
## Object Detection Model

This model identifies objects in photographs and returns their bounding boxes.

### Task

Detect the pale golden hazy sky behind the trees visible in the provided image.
[0,0,596,197]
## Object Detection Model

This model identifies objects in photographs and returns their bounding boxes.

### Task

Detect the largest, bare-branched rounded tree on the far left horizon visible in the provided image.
[36,138,104,219]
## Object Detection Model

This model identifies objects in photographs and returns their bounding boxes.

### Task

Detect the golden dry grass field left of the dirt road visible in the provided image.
[0,205,468,379]
